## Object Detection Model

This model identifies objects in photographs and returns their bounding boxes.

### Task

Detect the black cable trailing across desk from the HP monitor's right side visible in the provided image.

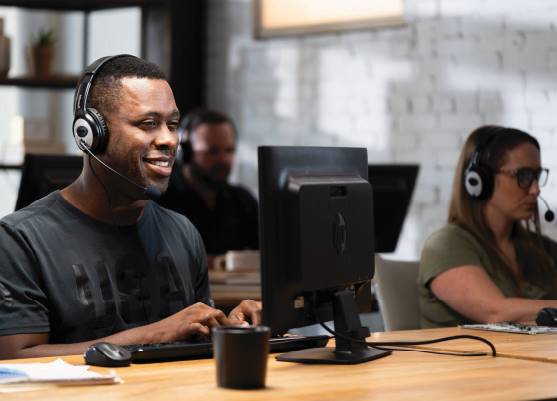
[310,294,497,356]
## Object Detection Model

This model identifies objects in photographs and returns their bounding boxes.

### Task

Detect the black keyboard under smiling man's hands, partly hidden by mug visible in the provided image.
[123,335,330,363]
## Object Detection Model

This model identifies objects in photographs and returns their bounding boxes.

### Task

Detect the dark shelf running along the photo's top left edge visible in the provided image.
[0,0,169,11]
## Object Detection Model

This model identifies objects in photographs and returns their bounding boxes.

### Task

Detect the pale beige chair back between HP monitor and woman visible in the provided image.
[373,255,420,331]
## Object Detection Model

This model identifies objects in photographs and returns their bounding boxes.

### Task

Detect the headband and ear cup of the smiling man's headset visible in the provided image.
[72,54,136,154]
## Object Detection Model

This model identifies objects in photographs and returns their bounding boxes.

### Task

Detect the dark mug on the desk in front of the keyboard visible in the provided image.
[213,326,271,389]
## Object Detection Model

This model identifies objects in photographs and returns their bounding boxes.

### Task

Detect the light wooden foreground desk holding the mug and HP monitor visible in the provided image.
[0,342,557,401]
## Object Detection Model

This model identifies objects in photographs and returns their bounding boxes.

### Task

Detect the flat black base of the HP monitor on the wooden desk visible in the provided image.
[276,347,391,365]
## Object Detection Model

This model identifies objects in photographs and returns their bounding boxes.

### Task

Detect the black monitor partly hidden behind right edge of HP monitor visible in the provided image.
[368,164,419,253]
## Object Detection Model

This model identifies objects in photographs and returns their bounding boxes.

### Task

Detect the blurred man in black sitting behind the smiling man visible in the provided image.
[160,109,258,255]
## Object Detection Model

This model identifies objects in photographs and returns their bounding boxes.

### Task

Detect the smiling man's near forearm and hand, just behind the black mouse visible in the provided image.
[0,302,234,359]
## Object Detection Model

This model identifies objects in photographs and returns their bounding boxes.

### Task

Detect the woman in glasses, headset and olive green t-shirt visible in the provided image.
[418,126,557,327]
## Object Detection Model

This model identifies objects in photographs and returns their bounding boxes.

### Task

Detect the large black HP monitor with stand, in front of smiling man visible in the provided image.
[258,146,388,363]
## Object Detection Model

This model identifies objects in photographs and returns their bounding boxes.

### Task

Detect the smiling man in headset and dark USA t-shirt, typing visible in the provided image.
[0,55,260,359]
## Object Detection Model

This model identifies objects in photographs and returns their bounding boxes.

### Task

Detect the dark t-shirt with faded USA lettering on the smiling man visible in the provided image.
[0,192,210,343]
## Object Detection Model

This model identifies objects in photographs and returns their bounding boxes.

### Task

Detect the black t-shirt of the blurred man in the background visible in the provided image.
[159,168,258,255]
